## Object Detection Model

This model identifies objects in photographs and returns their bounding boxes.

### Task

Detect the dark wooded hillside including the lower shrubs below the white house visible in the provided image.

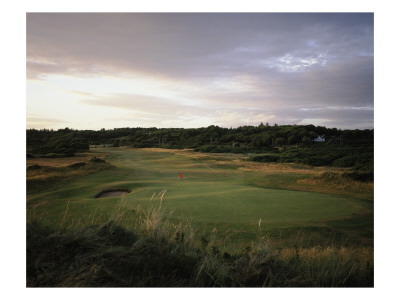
[27,123,374,167]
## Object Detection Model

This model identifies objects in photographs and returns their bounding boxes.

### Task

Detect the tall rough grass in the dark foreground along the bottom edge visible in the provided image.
[27,203,373,287]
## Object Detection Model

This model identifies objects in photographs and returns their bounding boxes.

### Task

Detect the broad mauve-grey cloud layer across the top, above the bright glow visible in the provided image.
[27,14,372,77]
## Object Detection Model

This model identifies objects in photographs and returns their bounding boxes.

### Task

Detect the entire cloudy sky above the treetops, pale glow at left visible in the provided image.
[26,13,374,129]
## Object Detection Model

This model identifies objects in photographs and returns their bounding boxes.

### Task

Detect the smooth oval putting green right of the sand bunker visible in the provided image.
[119,181,361,226]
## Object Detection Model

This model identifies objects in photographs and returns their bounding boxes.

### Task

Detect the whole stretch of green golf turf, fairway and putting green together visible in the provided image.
[28,147,372,247]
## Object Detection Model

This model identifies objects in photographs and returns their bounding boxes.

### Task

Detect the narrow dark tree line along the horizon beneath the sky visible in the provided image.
[26,123,374,153]
